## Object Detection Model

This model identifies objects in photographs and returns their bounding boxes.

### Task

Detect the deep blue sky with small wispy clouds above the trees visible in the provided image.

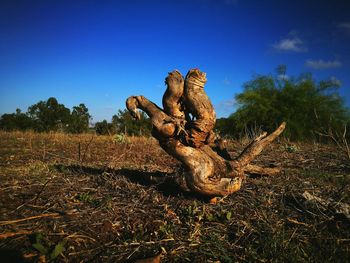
[0,0,350,121]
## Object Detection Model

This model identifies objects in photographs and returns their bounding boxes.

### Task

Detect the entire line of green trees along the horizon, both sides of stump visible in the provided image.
[0,65,350,140]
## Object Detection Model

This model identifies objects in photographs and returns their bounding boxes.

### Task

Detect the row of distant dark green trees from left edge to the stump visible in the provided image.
[0,97,152,135]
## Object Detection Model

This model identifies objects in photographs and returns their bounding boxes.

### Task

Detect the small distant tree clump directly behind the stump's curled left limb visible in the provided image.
[112,110,152,136]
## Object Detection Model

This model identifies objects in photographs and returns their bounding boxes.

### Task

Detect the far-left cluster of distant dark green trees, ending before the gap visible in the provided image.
[0,97,91,133]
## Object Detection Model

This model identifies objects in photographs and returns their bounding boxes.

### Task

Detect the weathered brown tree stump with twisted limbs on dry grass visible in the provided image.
[126,69,285,196]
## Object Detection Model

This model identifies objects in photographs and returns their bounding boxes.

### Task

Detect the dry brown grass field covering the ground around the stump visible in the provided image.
[0,132,350,262]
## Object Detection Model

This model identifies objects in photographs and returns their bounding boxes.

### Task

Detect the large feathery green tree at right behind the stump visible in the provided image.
[216,65,350,140]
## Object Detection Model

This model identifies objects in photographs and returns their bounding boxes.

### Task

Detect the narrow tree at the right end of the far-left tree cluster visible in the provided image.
[67,103,91,133]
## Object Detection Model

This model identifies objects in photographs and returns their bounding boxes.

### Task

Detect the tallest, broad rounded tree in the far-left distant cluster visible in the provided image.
[28,97,70,131]
